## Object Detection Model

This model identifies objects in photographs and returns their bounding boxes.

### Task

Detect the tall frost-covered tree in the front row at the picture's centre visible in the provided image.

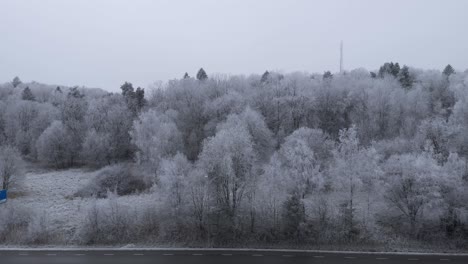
[199,119,257,232]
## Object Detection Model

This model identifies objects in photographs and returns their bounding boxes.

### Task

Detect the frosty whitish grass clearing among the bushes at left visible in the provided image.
[10,169,155,243]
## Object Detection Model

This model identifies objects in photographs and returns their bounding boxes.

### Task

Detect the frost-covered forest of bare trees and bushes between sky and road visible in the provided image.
[0,62,468,251]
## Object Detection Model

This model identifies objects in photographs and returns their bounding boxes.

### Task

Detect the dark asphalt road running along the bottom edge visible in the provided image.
[0,249,468,264]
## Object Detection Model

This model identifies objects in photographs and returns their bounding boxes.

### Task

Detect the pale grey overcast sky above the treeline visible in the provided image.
[0,0,468,91]
